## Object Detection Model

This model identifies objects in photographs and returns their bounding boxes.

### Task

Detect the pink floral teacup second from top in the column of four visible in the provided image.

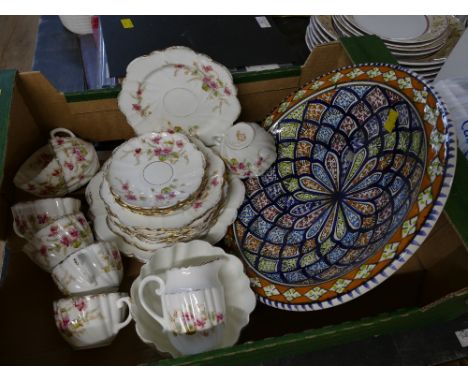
[23,212,94,272]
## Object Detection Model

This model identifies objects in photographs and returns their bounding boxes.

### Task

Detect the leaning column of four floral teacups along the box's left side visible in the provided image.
[12,198,131,349]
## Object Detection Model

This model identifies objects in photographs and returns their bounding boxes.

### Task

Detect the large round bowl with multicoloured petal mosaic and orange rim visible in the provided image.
[234,64,456,311]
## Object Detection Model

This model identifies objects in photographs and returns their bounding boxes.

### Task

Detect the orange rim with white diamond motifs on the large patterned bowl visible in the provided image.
[233,63,457,311]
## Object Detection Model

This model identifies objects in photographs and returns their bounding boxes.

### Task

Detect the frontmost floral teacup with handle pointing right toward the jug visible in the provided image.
[53,293,132,350]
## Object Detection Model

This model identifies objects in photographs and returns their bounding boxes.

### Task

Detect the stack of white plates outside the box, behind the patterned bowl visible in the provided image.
[306,15,463,81]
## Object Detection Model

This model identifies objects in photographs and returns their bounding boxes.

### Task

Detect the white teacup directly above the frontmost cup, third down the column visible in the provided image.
[52,242,123,296]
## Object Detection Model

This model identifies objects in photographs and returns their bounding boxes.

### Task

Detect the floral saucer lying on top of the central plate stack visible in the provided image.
[105,131,206,212]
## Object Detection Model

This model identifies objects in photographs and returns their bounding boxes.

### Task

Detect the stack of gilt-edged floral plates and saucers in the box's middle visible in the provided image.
[86,129,244,261]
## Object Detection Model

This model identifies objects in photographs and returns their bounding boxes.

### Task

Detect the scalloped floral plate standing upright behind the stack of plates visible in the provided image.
[118,46,241,146]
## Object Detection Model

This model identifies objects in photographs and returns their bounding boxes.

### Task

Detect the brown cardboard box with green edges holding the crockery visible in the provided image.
[0,43,468,365]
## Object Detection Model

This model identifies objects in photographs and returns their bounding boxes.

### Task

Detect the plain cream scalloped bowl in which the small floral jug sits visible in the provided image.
[130,240,256,357]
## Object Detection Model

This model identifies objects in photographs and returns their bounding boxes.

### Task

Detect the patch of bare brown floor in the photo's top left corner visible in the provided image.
[0,16,39,71]
